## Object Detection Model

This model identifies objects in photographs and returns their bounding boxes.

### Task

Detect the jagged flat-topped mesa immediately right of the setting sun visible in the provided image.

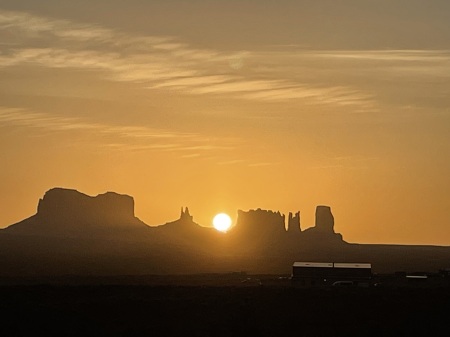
[236,208,286,233]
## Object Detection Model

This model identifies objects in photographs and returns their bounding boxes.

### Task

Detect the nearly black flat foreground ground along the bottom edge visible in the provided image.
[0,274,450,337]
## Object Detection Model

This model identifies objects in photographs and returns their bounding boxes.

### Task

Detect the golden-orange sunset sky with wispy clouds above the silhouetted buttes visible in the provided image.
[0,0,450,245]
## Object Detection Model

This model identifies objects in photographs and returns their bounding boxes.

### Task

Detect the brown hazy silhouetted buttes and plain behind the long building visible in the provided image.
[0,188,450,277]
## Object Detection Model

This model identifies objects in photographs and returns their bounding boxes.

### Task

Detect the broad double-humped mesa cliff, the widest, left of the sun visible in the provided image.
[37,188,136,224]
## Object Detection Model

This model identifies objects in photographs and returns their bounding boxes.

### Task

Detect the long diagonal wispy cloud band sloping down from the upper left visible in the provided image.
[0,10,373,108]
